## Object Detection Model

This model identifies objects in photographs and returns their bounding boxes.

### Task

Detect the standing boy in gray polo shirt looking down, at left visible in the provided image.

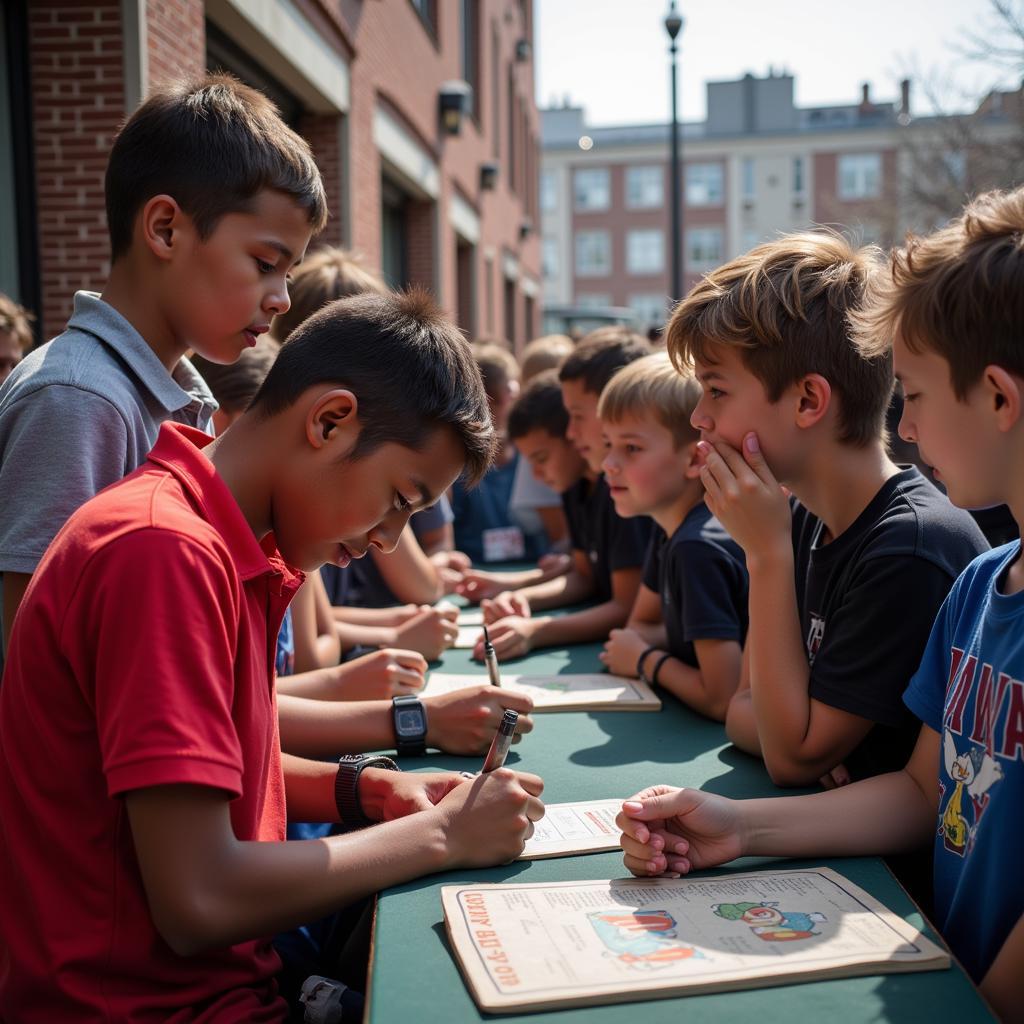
[0,75,327,642]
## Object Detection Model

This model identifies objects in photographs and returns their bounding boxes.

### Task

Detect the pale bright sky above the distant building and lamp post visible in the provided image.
[535,0,1019,125]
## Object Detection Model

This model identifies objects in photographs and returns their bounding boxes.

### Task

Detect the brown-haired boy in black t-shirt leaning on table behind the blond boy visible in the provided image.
[474,328,650,658]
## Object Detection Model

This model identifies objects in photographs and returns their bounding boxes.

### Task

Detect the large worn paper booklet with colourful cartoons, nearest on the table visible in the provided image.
[441,867,949,1011]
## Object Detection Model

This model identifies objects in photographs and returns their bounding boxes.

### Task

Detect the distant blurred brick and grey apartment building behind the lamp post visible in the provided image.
[540,73,1024,335]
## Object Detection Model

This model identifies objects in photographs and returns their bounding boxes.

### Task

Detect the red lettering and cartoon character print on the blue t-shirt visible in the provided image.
[938,647,1024,857]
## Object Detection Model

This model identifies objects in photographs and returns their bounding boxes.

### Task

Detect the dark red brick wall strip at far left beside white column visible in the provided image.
[29,0,124,338]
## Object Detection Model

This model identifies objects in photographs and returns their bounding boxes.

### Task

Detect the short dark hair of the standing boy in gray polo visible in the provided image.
[105,73,327,260]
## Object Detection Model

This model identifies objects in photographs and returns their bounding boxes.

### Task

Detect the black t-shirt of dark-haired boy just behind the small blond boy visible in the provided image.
[562,474,651,601]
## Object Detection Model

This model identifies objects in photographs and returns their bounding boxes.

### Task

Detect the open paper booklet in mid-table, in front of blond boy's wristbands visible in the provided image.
[417,672,662,712]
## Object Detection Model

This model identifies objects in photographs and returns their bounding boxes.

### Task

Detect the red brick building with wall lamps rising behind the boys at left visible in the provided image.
[0,0,540,346]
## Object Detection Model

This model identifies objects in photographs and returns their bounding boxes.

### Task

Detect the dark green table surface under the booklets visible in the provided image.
[366,644,992,1024]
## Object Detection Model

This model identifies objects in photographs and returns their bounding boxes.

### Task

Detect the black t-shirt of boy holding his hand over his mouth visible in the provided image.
[793,467,988,778]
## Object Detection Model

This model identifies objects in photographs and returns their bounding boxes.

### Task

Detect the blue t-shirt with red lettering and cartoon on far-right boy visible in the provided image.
[904,541,1024,982]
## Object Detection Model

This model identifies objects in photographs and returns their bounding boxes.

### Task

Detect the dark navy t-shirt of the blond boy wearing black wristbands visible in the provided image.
[643,502,748,668]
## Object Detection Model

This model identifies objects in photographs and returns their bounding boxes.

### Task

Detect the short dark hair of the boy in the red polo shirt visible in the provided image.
[250,288,498,484]
